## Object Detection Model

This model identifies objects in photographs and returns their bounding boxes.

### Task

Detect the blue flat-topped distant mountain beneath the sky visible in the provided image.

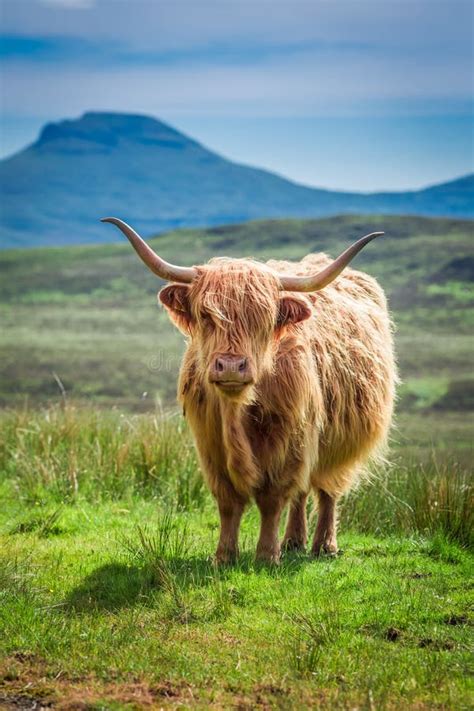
[0,112,474,247]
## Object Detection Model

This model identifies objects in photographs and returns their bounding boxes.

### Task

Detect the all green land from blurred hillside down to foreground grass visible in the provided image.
[0,217,474,711]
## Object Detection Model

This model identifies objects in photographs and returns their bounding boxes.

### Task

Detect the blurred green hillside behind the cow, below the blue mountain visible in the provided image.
[0,216,474,458]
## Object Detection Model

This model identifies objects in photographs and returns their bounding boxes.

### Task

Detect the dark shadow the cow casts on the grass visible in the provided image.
[65,553,312,612]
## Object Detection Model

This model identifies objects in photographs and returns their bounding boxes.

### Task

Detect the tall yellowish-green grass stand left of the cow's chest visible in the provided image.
[0,405,205,509]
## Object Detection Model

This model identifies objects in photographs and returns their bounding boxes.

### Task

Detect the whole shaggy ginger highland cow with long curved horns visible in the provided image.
[104,217,396,562]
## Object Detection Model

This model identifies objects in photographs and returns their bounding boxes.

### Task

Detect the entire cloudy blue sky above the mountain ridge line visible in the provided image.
[0,0,473,191]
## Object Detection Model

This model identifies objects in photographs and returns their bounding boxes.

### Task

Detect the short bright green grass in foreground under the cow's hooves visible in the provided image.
[0,492,473,709]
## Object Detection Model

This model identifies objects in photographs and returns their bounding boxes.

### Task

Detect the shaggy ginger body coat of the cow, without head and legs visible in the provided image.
[179,270,396,499]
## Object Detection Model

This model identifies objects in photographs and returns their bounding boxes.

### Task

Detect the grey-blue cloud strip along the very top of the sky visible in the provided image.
[2,0,472,51]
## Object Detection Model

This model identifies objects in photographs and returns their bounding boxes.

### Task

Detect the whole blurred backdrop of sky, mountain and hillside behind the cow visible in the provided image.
[0,0,474,466]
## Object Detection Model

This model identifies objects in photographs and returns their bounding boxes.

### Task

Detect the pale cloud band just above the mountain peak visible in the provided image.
[3,41,469,124]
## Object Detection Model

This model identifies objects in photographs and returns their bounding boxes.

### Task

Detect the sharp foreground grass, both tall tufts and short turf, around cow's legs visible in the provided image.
[0,407,474,710]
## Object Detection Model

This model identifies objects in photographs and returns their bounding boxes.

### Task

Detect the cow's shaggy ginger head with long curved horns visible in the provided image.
[103,217,383,401]
